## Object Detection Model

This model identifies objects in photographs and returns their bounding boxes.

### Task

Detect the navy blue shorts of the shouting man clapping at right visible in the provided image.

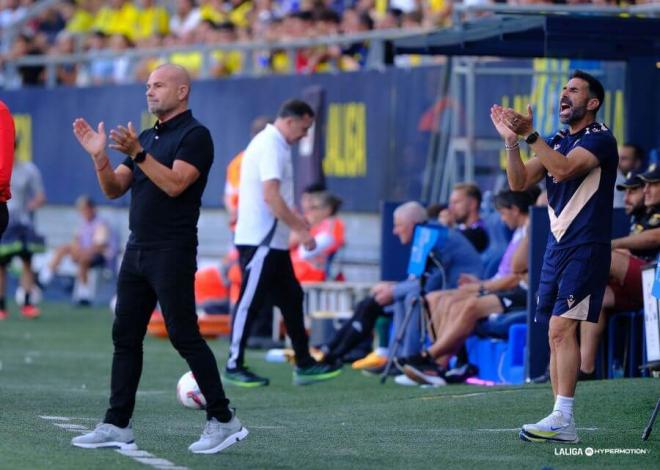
[535,244,612,323]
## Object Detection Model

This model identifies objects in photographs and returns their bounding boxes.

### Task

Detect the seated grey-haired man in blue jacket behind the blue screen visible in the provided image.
[321,202,482,372]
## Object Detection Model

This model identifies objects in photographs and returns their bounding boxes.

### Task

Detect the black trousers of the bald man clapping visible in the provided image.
[105,247,231,428]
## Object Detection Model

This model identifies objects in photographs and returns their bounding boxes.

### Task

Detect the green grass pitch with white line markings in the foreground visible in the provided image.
[0,304,660,470]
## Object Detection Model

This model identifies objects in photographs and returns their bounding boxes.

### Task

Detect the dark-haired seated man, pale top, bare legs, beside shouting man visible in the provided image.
[401,190,538,385]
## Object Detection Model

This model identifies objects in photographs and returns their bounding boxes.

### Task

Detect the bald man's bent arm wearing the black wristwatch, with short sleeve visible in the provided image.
[110,122,212,197]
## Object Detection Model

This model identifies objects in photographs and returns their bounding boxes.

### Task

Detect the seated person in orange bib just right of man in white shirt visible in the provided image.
[291,191,345,282]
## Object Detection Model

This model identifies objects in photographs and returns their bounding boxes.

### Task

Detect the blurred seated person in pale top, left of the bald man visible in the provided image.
[39,196,117,305]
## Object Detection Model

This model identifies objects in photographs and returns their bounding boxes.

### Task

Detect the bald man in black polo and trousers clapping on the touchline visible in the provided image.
[72,64,248,454]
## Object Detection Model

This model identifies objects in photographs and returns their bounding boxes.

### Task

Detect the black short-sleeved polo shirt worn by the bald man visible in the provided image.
[123,110,213,248]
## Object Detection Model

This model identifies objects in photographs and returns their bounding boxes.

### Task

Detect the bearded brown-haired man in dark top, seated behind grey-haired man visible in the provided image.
[449,183,488,253]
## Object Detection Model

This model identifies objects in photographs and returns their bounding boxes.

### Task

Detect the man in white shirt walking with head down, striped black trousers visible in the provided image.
[223,100,341,387]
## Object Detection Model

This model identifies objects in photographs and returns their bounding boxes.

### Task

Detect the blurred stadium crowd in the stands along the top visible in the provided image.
[0,0,646,86]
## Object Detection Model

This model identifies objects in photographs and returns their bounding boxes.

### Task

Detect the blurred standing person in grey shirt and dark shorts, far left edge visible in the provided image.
[0,154,46,318]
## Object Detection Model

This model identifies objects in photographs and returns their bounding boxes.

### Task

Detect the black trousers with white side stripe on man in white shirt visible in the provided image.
[227,245,314,369]
